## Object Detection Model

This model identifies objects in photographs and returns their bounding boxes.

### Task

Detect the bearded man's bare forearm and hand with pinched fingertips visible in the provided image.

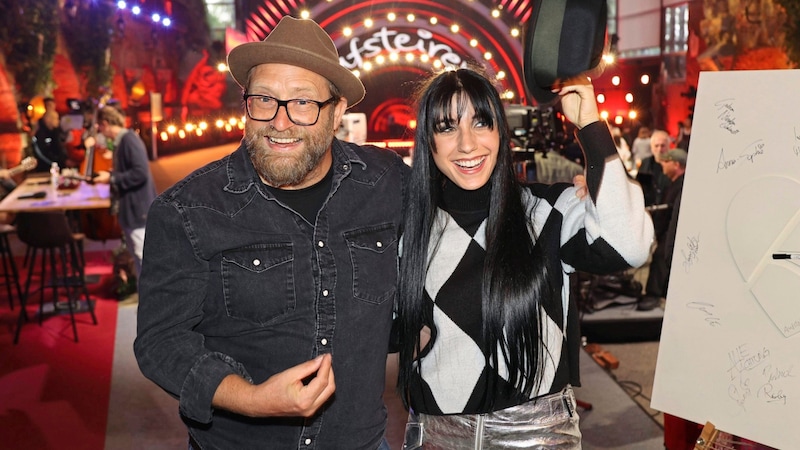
[212,354,336,417]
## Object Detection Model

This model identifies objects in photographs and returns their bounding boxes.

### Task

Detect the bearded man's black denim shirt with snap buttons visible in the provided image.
[134,140,409,450]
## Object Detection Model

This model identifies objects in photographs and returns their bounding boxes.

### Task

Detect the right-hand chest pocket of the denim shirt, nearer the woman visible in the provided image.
[344,224,397,304]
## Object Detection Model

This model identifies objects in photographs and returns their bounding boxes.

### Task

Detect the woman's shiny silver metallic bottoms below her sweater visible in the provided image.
[403,386,581,450]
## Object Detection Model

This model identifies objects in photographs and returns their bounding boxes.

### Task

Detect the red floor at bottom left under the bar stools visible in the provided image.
[0,254,117,450]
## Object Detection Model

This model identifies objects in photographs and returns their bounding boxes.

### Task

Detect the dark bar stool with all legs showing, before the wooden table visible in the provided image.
[14,211,97,344]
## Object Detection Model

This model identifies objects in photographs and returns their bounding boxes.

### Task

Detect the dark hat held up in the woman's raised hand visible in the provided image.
[523,0,608,104]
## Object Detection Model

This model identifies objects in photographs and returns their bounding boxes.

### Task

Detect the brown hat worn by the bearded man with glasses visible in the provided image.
[228,16,364,107]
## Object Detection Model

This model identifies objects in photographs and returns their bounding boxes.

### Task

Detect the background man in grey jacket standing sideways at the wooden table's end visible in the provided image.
[85,106,156,275]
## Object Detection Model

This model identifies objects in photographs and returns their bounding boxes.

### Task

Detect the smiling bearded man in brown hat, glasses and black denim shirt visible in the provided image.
[134,17,408,450]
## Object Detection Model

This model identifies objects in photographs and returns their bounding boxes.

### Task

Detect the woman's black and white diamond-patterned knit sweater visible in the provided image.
[409,122,653,415]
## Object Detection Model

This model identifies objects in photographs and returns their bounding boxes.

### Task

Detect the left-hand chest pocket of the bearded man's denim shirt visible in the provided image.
[221,243,295,325]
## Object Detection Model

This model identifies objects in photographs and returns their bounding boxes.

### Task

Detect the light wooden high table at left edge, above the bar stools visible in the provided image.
[0,177,111,212]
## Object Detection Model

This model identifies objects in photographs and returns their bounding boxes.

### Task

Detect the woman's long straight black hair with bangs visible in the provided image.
[397,68,557,407]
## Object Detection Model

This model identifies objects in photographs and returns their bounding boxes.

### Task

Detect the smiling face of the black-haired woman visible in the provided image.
[433,94,500,190]
